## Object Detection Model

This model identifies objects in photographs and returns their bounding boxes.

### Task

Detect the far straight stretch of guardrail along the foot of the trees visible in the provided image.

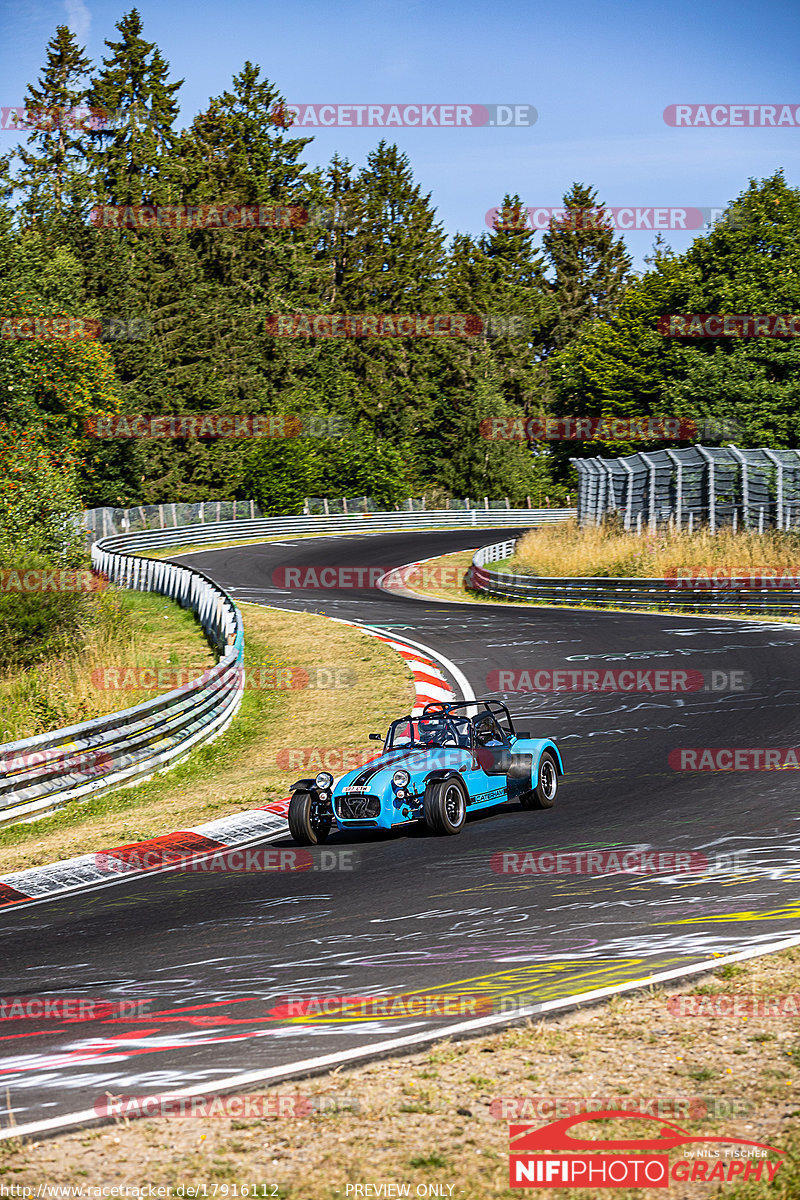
[98,509,577,551]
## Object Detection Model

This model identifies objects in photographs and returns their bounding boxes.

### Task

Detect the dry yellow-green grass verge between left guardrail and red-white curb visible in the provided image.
[0,605,413,874]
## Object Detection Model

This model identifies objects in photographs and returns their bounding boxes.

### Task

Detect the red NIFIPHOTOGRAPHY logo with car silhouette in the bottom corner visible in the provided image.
[509,1109,784,1188]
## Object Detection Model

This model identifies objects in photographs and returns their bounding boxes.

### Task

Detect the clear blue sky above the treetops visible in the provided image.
[0,0,800,268]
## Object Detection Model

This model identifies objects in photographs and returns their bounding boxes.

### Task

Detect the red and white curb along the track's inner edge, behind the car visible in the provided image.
[0,618,474,910]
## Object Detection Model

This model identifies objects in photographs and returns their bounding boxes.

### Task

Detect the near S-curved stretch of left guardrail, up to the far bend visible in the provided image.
[0,539,245,826]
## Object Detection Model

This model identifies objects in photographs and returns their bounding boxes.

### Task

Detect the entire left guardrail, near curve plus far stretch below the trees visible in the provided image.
[0,509,576,826]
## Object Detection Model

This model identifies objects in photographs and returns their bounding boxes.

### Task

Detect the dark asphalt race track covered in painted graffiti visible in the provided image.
[0,529,800,1126]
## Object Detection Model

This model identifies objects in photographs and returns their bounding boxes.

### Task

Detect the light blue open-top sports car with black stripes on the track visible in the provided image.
[289,700,564,846]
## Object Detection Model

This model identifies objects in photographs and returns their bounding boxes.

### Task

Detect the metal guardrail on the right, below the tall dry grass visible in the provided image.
[468,539,800,614]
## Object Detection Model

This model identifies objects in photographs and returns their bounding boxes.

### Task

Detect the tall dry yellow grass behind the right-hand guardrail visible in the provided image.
[513,521,800,578]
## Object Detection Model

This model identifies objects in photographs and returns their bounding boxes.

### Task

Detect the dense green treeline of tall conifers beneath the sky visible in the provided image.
[0,10,800,512]
